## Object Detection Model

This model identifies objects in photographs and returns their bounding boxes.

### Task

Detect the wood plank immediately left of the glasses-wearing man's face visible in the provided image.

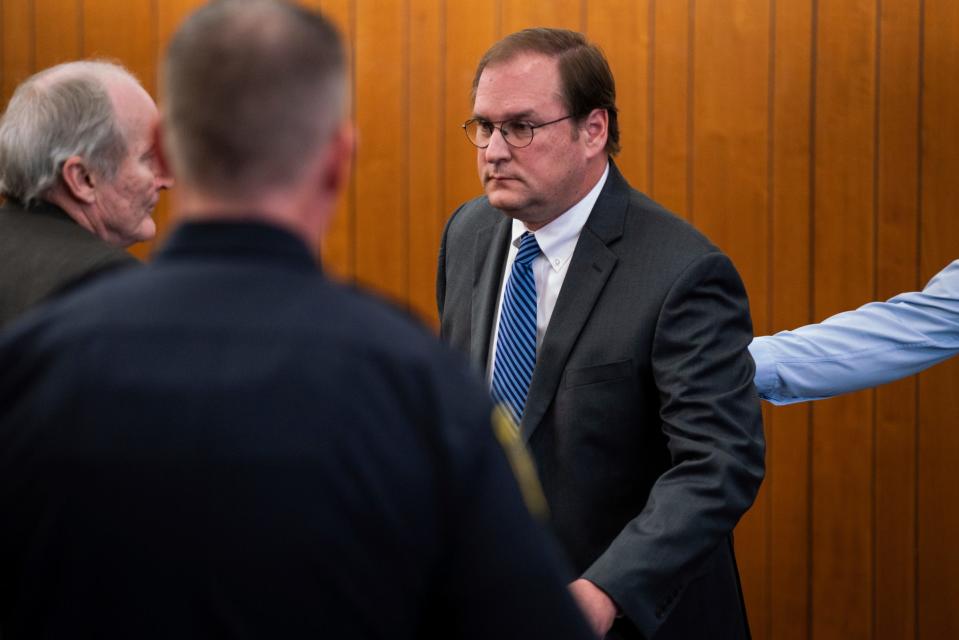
[443,0,498,212]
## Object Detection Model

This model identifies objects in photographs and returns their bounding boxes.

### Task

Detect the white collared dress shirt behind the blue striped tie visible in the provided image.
[486,163,609,380]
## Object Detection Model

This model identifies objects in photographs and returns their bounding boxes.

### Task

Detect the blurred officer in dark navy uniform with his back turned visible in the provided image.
[0,0,589,639]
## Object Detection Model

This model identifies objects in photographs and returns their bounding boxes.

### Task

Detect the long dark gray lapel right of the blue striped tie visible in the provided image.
[520,162,629,440]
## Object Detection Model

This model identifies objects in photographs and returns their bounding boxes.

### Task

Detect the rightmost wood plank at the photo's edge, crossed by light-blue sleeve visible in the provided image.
[918,0,959,638]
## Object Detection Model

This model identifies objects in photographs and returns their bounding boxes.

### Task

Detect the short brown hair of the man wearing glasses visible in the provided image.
[471,27,619,156]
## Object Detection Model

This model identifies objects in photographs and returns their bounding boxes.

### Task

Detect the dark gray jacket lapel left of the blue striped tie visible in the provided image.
[470,216,512,372]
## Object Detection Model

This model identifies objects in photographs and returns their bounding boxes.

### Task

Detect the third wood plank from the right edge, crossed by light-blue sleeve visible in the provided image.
[812,0,877,638]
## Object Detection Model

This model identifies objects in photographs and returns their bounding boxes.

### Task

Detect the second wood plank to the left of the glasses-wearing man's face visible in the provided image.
[407,0,446,326]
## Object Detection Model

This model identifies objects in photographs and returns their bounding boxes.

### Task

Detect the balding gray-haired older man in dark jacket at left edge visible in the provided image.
[0,61,170,326]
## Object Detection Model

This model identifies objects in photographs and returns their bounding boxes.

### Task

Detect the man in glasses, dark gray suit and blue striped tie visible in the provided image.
[437,29,764,640]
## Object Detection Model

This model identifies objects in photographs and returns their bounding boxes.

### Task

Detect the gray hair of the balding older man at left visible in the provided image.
[0,60,137,204]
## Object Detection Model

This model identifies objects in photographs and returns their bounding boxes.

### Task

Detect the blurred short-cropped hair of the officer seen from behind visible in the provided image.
[161,0,347,197]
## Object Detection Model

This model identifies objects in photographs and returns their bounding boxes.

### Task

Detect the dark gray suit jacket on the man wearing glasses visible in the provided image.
[437,164,764,639]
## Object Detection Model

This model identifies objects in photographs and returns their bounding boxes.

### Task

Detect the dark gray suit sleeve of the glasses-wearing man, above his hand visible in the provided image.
[583,252,765,637]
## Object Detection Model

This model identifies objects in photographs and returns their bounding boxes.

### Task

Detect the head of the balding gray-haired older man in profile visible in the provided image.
[0,61,170,246]
